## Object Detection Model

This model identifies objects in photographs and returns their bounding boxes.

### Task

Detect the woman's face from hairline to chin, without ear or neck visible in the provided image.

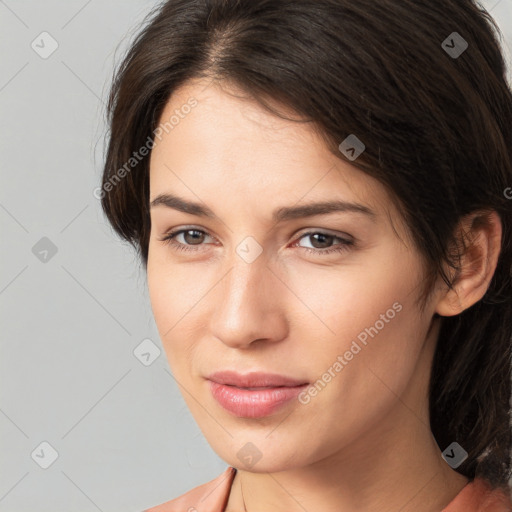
[147,82,435,472]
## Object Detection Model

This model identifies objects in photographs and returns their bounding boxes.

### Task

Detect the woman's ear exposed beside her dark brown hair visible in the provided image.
[435,210,502,316]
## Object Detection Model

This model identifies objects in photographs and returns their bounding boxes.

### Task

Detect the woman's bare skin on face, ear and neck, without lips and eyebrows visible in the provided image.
[147,77,501,512]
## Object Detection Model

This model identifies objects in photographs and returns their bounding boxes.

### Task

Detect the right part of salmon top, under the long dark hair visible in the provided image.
[442,478,512,512]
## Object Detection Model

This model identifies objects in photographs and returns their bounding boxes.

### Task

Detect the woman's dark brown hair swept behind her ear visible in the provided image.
[100,0,512,486]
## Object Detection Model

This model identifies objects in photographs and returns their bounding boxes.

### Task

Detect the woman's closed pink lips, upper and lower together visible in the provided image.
[208,371,308,418]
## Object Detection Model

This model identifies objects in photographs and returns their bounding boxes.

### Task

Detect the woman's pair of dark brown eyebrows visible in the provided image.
[150,194,377,222]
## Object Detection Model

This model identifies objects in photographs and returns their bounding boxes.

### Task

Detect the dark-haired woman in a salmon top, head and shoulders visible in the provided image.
[101,0,512,512]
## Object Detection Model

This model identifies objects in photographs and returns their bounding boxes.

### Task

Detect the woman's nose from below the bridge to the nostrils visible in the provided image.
[210,252,288,349]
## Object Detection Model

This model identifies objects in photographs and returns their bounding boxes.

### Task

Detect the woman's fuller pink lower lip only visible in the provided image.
[208,381,308,418]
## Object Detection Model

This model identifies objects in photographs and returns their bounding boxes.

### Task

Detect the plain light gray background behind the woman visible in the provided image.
[0,0,512,512]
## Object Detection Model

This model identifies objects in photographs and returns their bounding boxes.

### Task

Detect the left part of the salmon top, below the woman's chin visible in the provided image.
[144,466,236,512]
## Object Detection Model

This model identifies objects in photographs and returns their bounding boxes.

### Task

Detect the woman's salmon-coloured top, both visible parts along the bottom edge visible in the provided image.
[144,467,512,512]
